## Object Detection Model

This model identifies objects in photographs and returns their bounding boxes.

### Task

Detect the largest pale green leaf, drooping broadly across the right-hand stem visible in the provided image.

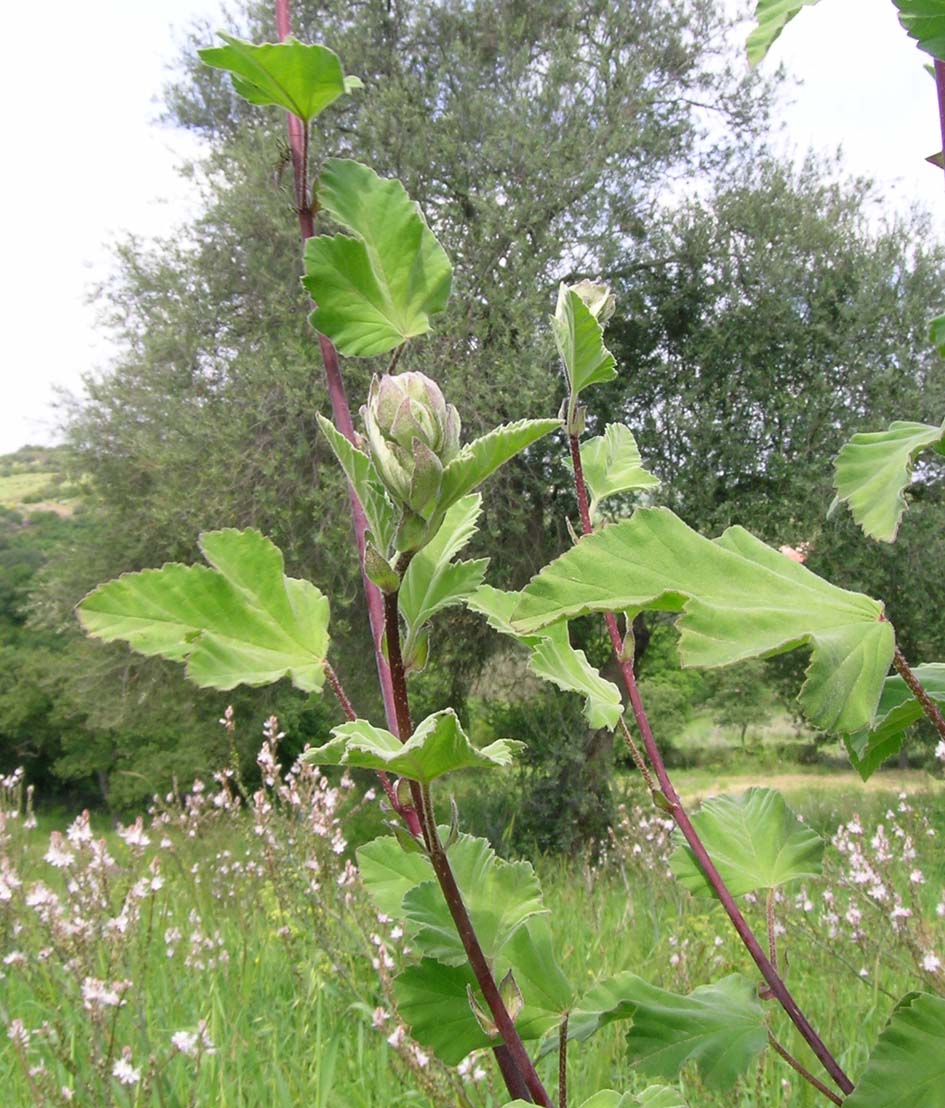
[512,509,894,731]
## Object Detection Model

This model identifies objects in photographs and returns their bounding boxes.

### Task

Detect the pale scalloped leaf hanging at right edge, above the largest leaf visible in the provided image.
[833,420,945,543]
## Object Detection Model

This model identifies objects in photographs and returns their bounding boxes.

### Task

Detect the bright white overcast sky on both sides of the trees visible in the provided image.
[0,0,945,453]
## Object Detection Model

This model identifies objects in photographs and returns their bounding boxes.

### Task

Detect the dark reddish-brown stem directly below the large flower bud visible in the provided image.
[384,585,552,1108]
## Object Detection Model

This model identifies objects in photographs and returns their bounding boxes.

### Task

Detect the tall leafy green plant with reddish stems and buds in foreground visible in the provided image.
[70,0,945,1108]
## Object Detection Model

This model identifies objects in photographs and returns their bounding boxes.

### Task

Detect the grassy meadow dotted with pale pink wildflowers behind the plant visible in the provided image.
[0,720,945,1108]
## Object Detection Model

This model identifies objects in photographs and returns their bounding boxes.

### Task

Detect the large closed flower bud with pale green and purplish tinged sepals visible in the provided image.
[361,372,460,515]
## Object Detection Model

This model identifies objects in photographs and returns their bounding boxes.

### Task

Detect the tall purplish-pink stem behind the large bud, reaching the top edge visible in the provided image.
[276,0,397,733]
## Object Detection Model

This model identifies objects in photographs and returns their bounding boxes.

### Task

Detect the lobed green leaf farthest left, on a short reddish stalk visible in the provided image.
[78,529,328,693]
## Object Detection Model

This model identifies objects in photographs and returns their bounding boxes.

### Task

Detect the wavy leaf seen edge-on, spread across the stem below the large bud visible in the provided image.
[302,708,525,781]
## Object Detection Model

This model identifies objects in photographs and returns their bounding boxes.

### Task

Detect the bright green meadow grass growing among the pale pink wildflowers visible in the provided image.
[0,769,945,1108]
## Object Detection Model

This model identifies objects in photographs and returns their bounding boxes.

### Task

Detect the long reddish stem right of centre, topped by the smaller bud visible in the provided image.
[569,435,853,1094]
